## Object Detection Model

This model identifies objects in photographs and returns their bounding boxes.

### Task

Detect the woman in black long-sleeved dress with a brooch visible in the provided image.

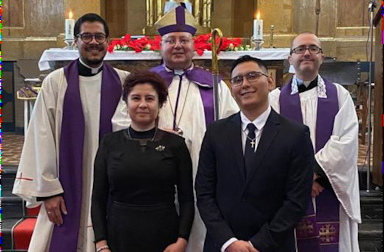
[91,71,194,252]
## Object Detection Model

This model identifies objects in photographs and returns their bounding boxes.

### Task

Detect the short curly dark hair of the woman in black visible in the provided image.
[123,70,168,108]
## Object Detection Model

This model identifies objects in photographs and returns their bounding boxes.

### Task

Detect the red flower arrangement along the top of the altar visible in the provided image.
[108,33,251,55]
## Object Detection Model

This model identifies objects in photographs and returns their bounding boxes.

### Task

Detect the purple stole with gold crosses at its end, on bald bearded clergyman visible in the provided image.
[280,79,340,252]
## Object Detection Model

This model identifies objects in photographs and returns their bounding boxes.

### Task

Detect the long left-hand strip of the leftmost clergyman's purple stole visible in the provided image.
[49,60,85,252]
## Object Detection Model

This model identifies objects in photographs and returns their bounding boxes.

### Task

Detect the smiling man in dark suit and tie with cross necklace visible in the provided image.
[196,56,314,252]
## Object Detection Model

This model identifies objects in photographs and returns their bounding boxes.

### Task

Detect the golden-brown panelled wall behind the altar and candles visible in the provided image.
[2,0,380,130]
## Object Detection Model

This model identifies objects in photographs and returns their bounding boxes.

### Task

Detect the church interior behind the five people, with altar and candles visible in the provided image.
[0,0,383,252]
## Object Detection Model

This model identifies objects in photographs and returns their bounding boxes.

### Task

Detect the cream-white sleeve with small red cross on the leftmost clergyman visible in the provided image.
[12,74,63,206]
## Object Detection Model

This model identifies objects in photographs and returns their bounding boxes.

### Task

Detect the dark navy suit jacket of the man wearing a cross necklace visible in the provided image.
[195,109,314,252]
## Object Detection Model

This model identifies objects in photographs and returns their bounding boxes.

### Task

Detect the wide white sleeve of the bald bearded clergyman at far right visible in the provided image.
[315,85,361,222]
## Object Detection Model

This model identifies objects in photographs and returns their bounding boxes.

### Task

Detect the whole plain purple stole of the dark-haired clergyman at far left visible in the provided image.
[49,60,122,252]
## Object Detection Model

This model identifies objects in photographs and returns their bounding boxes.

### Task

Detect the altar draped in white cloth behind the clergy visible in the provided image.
[38,48,290,87]
